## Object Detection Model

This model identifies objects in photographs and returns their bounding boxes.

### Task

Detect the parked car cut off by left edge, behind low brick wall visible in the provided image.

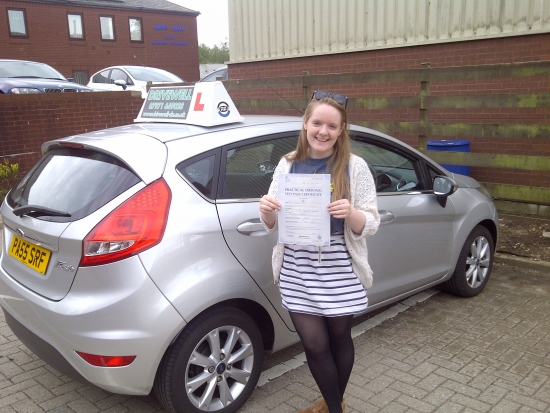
[0,59,92,95]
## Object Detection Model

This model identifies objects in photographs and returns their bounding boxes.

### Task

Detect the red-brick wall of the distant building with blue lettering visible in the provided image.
[0,1,200,81]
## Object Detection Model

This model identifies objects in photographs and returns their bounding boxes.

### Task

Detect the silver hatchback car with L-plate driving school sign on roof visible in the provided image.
[0,82,498,413]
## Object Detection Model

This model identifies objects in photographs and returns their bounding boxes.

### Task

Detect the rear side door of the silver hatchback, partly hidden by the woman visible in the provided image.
[216,131,298,330]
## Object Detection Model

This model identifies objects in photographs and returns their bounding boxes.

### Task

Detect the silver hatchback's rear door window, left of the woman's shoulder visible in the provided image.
[218,135,298,199]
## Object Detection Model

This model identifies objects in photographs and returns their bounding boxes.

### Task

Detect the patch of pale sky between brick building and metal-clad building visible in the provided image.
[169,0,229,47]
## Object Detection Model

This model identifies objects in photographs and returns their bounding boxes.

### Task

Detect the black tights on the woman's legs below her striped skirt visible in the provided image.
[290,312,355,413]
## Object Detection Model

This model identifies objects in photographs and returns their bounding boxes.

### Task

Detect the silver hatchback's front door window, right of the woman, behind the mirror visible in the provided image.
[351,137,429,193]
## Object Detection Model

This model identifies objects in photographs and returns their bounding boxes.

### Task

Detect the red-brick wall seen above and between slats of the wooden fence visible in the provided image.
[229,33,550,191]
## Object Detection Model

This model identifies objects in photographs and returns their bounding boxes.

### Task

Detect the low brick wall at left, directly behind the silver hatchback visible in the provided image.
[0,92,143,173]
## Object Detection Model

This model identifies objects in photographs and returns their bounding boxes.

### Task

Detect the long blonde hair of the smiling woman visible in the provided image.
[285,97,350,201]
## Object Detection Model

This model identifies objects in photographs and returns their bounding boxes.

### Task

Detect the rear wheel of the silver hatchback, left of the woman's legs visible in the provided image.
[155,308,263,413]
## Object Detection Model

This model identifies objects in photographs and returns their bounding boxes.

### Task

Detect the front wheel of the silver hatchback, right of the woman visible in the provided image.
[443,225,495,297]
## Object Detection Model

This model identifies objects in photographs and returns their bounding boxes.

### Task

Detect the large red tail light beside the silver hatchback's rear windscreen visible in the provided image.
[80,178,172,267]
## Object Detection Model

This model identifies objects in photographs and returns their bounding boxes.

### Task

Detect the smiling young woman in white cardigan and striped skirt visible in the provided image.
[260,91,380,413]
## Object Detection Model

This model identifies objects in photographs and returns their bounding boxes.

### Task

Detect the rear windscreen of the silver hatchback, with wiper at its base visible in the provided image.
[6,148,140,222]
